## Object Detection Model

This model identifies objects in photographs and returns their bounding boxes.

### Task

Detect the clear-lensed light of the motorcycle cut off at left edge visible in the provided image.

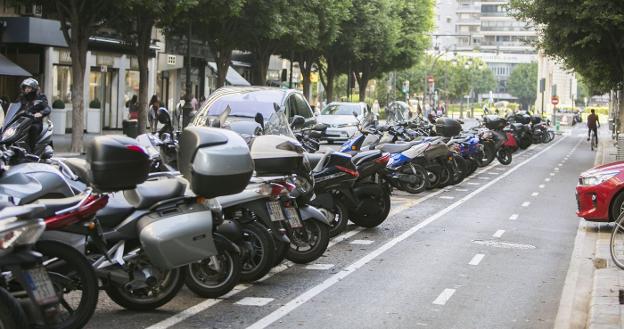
[0,218,45,255]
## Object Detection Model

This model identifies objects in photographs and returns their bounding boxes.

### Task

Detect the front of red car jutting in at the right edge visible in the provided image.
[576,161,624,222]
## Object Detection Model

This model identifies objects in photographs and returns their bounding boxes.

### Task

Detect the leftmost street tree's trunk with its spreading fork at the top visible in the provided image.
[14,0,111,152]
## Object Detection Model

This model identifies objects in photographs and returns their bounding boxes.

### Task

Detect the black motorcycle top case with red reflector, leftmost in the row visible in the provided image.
[87,136,150,192]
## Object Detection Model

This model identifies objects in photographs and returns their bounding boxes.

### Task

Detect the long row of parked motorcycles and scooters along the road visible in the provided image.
[0,98,556,328]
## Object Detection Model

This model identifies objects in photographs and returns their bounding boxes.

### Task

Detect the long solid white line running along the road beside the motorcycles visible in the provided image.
[247,136,566,329]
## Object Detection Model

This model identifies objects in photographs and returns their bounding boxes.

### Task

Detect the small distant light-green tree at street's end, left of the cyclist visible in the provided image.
[507,62,537,110]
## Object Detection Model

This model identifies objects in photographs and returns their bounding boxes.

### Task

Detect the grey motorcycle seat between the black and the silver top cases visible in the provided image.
[123,178,186,209]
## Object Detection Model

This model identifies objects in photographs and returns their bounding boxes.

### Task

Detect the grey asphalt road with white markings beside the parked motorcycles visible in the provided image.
[88,124,594,329]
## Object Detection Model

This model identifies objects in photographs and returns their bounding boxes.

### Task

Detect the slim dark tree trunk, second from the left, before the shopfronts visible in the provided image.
[137,14,152,135]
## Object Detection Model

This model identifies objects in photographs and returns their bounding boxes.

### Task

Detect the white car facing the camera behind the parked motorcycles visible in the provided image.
[317,102,376,143]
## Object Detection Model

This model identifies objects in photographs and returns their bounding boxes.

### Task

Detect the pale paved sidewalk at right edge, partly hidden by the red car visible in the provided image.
[554,131,624,329]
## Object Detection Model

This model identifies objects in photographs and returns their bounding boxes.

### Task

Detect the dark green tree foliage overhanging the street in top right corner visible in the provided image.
[510,0,624,93]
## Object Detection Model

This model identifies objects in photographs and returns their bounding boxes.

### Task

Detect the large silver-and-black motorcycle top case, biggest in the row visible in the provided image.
[178,127,254,198]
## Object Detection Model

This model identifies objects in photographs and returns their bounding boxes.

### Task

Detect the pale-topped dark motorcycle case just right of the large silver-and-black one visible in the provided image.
[251,135,310,176]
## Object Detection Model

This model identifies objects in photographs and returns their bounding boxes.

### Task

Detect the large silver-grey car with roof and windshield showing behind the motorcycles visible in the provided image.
[192,86,316,135]
